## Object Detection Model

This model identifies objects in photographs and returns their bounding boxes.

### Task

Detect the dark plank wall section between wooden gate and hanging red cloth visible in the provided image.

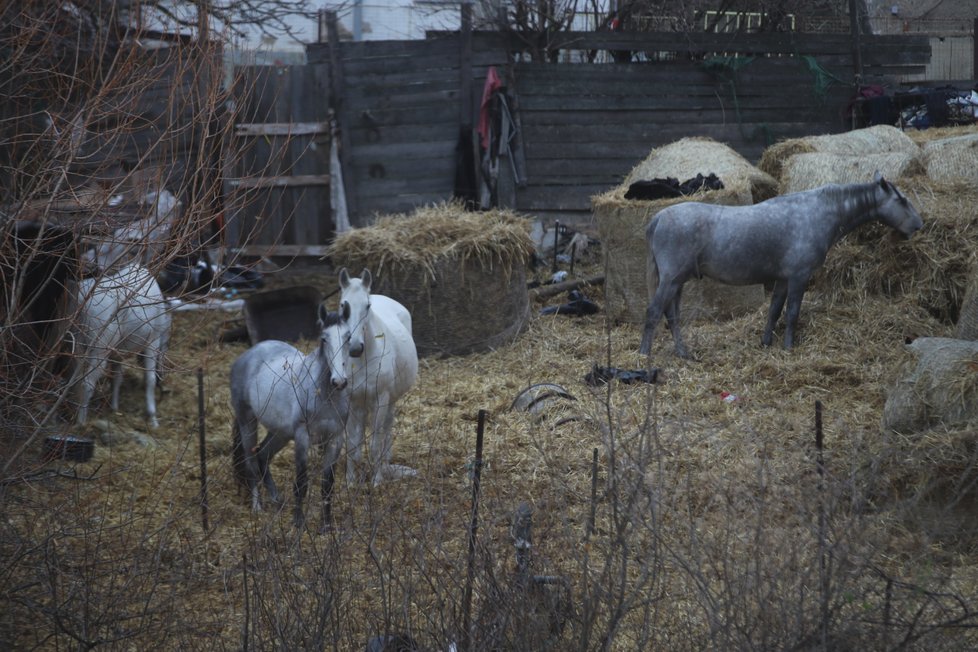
[307,34,506,226]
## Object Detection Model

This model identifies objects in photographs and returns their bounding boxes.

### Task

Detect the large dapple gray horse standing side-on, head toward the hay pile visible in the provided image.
[640,173,923,358]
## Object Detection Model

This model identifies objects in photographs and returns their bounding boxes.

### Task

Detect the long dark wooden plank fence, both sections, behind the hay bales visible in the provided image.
[227,17,930,252]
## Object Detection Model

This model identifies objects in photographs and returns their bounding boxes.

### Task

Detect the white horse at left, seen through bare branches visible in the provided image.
[74,264,171,428]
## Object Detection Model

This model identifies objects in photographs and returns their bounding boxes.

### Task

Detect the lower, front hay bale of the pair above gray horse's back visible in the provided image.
[781,152,924,193]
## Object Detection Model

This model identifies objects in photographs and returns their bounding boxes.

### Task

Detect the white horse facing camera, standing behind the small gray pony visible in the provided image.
[339,268,418,485]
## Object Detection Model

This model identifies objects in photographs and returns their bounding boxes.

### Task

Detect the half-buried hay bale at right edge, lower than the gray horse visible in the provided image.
[883,337,978,434]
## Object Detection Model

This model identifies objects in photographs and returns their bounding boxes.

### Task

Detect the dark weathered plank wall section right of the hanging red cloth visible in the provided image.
[514,33,927,221]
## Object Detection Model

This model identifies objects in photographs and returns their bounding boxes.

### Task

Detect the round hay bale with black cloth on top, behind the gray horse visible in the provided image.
[591,138,777,323]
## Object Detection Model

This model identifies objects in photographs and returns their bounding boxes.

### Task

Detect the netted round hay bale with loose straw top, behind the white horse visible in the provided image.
[327,203,533,357]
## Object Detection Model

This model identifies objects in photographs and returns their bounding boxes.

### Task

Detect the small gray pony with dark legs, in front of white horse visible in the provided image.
[230,305,349,532]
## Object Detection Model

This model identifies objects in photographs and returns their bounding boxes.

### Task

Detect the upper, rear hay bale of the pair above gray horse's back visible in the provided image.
[757,125,920,181]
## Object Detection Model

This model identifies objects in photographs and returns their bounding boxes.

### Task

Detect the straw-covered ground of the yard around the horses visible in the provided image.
[0,126,978,650]
